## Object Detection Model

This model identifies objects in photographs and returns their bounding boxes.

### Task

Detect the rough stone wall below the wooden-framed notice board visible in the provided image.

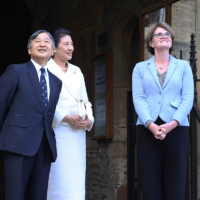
[86,128,127,200]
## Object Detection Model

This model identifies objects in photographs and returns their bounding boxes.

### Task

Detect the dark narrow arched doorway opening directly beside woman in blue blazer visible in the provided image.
[122,15,140,199]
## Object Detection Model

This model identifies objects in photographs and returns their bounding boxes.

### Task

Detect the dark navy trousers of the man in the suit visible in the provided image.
[4,133,51,200]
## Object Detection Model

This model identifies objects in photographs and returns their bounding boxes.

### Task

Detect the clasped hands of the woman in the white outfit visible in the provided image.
[63,115,92,129]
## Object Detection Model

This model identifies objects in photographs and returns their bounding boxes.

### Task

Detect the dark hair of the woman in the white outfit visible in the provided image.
[53,28,74,47]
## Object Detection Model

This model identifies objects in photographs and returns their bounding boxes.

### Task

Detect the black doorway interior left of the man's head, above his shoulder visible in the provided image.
[0,0,32,75]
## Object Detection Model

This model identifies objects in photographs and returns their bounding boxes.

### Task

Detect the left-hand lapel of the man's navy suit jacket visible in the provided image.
[27,61,44,110]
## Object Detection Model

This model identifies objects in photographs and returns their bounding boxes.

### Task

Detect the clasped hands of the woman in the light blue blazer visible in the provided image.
[148,120,178,140]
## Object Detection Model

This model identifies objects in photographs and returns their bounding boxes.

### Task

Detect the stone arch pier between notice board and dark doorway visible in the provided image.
[109,2,140,199]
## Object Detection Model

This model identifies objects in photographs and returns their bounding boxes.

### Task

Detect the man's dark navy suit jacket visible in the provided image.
[0,61,62,161]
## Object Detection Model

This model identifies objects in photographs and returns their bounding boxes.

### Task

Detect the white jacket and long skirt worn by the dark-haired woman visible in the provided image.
[47,59,94,200]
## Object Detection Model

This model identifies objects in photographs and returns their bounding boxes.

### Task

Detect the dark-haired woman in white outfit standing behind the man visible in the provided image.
[47,28,94,200]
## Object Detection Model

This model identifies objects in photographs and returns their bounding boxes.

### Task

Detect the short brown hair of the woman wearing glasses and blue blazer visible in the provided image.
[146,22,174,55]
